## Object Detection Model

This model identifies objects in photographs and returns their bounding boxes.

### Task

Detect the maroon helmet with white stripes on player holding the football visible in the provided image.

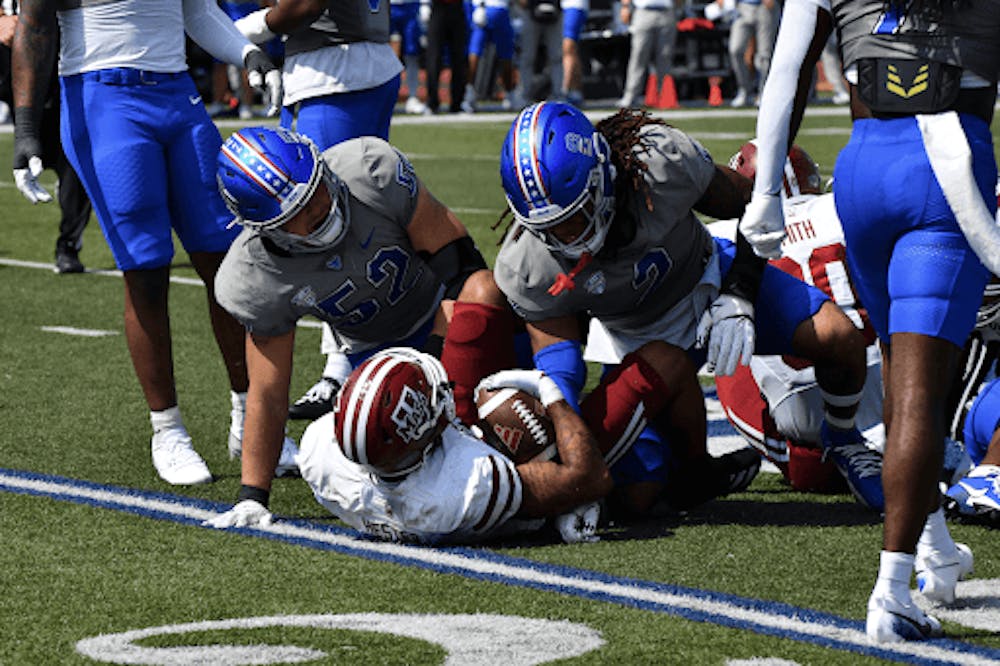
[333,347,455,480]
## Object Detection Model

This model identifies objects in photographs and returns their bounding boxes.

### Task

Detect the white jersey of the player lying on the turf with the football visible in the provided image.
[297,414,540,544]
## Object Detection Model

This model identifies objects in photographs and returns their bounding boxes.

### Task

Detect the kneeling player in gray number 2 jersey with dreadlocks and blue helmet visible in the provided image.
[494,103,865,510]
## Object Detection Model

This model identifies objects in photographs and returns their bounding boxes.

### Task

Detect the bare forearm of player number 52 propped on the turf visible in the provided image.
[242,330,295,490]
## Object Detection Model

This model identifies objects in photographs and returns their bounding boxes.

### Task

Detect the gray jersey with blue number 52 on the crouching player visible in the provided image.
[215,137,444,351]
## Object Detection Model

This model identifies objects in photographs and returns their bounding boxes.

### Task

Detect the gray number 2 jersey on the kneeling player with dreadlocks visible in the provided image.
[494,125,715,331]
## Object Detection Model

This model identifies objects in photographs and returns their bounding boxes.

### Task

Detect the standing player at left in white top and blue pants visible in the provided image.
[12,0,281,485]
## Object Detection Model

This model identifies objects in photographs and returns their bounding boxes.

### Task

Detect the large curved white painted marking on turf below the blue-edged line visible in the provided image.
[76,613,605,666]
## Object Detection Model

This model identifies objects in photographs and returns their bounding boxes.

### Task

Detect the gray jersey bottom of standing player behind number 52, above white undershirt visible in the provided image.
[285,0,389,57]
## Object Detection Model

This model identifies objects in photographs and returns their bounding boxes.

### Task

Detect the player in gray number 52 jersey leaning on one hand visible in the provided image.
[203,127,514,524]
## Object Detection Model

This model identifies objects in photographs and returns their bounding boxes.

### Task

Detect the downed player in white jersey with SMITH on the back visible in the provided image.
[708,141,884,511]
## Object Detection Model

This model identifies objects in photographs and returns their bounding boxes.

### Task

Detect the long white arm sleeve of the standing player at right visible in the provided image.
[753,0,830,194]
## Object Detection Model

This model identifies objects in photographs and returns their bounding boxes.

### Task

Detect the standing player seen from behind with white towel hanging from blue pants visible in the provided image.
[740,0,1000,642]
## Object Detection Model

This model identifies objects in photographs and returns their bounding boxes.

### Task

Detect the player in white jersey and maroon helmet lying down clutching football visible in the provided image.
[231,341,716,544]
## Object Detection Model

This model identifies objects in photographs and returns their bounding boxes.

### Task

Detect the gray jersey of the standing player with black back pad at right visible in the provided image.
[831,0,1000,82]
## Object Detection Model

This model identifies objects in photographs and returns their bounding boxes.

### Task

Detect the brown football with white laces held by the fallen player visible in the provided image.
[476,387,556,465]
